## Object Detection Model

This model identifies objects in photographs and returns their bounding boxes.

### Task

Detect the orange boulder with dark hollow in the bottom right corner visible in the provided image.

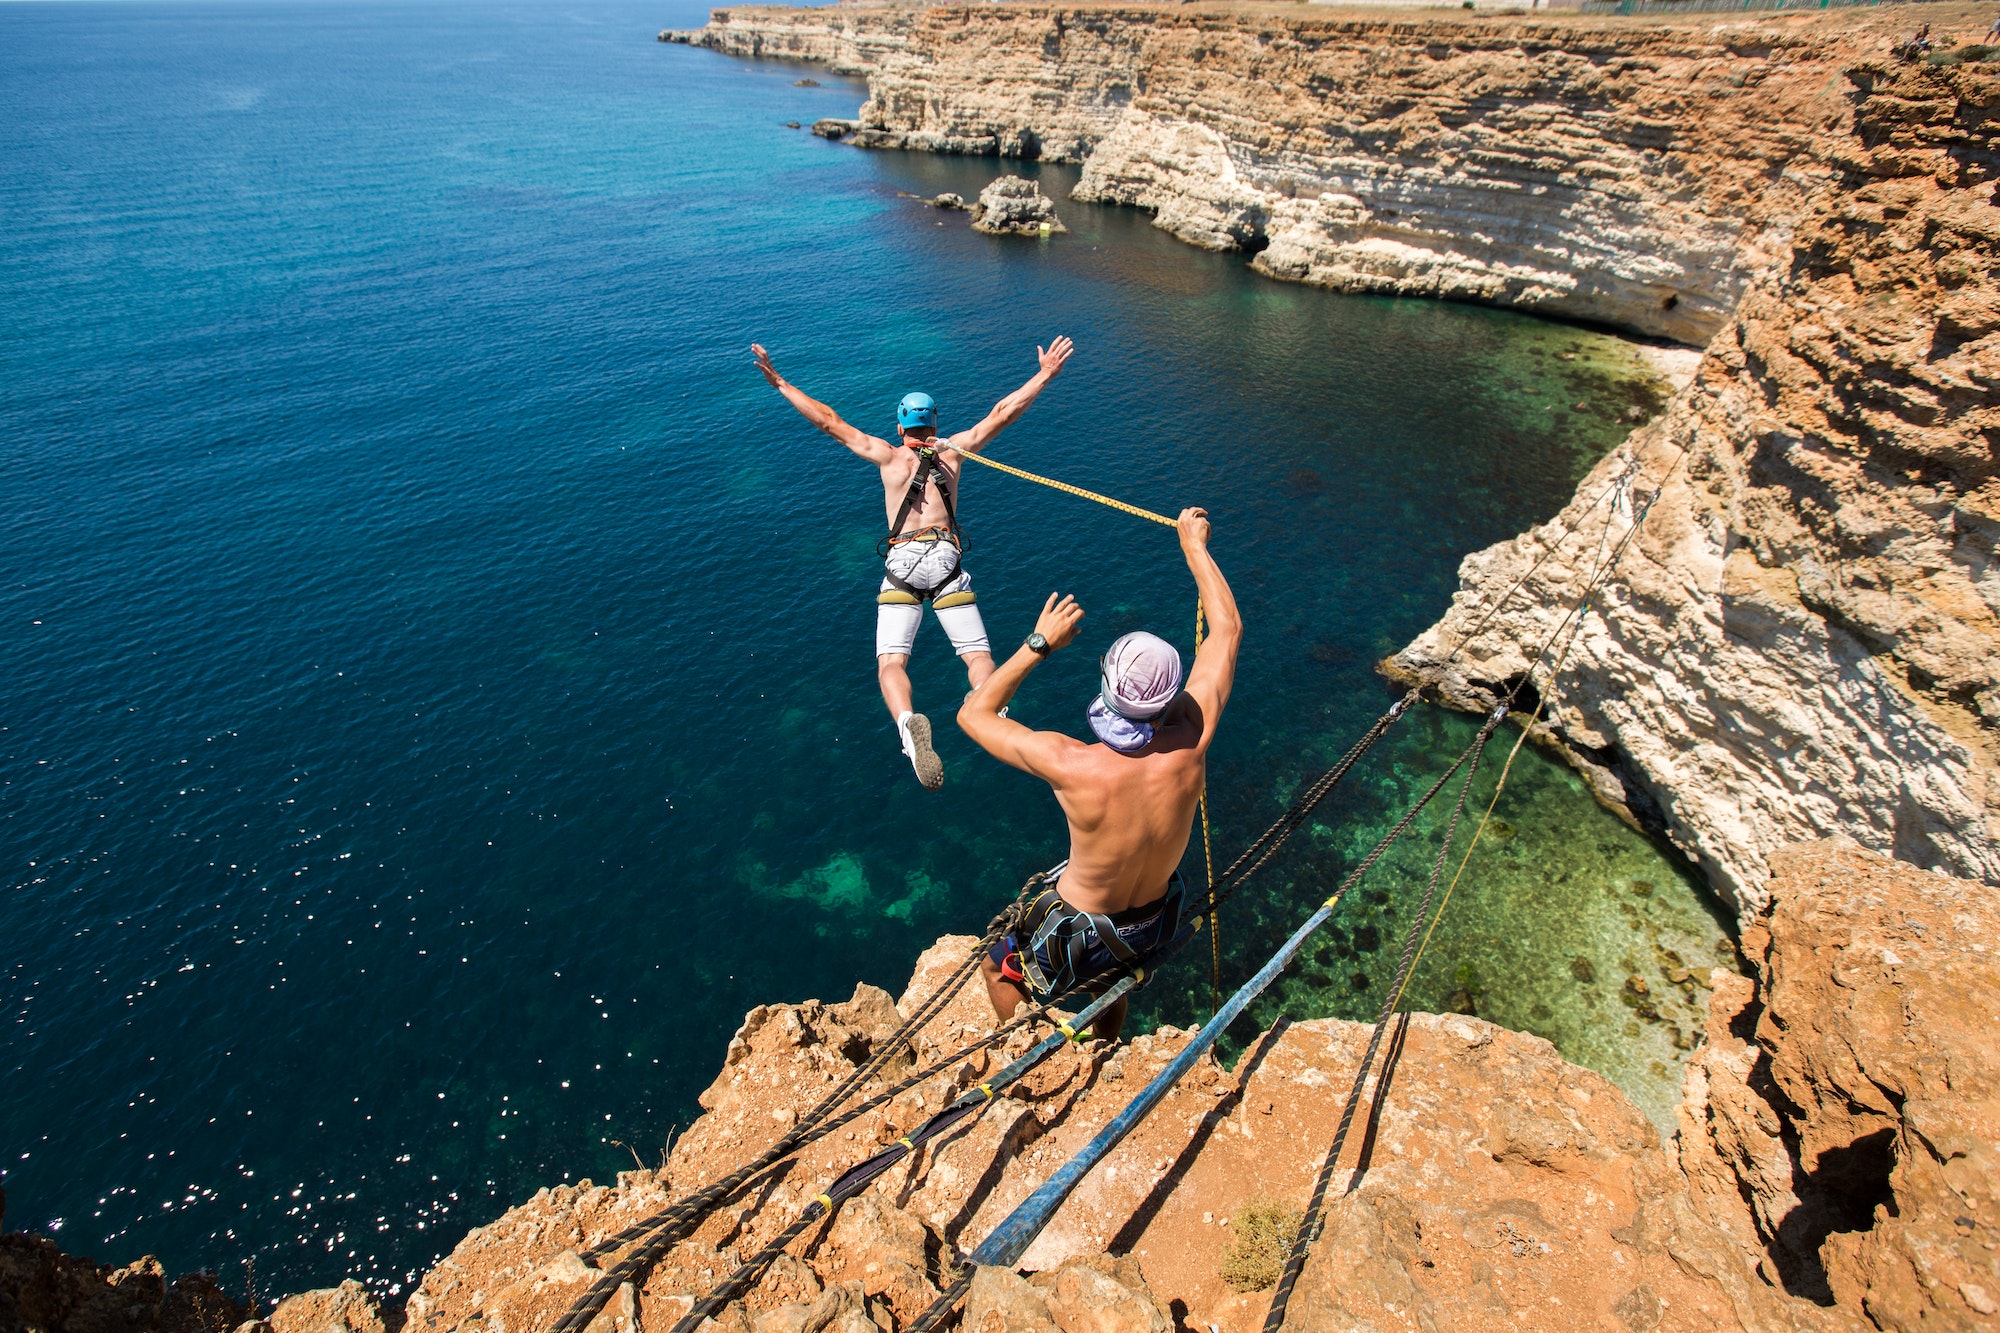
[1676,841,2000,1329]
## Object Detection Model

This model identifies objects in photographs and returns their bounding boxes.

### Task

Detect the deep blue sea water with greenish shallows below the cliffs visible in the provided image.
[0,2,1720,1291]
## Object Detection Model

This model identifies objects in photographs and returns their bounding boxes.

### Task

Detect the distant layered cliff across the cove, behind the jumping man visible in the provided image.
[674,4,1968,342]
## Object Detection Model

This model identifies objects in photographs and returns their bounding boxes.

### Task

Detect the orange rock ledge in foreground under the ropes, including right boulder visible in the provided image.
[368,841,2000,1333]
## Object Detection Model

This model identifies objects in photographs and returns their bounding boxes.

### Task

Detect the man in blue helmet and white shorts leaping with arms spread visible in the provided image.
[750,338,1074,791]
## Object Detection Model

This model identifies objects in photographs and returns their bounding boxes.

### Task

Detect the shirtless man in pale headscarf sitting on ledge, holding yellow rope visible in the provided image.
[958,508,1244,1041]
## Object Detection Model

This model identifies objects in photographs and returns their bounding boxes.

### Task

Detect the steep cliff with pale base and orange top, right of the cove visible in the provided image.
[1390,62,2000,911]
